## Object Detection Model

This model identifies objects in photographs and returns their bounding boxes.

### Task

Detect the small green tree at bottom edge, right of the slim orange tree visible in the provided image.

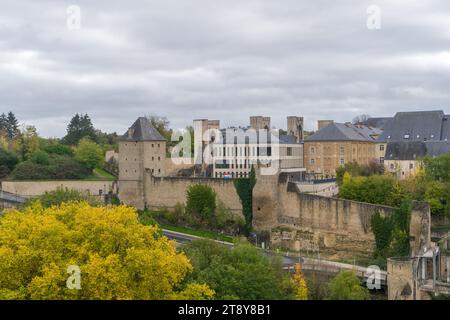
[328,271,370,300]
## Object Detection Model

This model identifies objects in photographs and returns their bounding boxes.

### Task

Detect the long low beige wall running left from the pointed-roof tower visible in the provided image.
[0,180,116,198]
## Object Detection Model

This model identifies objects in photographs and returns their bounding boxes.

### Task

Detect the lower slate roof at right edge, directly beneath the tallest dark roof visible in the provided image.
[385,141,450,160]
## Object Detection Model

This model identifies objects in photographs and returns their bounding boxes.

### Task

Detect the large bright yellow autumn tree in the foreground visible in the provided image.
[0,202,214,299]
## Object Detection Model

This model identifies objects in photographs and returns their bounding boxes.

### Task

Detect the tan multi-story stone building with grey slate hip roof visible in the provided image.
[304,120,381,178]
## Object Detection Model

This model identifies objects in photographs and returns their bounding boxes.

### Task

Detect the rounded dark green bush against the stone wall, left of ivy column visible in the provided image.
[186,184,216,220]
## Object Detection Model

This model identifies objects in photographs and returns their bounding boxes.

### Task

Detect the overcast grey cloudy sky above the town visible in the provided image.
[0,0,450,136]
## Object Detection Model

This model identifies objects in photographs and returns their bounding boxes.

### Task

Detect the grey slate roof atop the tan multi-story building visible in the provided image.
[307,122,382,141]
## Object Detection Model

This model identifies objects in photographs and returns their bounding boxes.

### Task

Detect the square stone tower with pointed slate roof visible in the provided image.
[119,117,166,209]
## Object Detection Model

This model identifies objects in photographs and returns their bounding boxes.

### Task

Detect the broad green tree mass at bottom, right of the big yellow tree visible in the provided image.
[182,240,295,300]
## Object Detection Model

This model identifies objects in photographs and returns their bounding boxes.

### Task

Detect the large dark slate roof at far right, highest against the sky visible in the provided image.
[379,110,450,142]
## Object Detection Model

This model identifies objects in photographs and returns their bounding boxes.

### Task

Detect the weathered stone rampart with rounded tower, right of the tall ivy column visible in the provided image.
[253,171,395,255]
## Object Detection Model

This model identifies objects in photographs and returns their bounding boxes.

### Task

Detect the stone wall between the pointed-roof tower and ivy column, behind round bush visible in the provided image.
[144,172,242,214]
